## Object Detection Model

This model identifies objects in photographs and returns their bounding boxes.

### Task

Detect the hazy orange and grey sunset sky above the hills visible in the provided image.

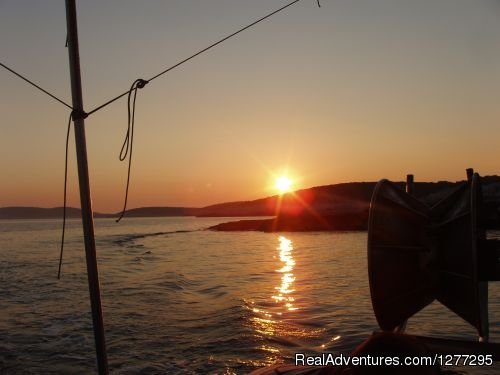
[0,0,500,212]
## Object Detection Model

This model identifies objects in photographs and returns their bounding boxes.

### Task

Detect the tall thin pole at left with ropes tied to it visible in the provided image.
[66,0,108,375]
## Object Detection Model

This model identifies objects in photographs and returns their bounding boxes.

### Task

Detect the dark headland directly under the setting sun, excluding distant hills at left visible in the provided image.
[206,176,500,232]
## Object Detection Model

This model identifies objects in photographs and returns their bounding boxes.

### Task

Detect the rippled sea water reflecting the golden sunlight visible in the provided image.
[0,218,500,374]
